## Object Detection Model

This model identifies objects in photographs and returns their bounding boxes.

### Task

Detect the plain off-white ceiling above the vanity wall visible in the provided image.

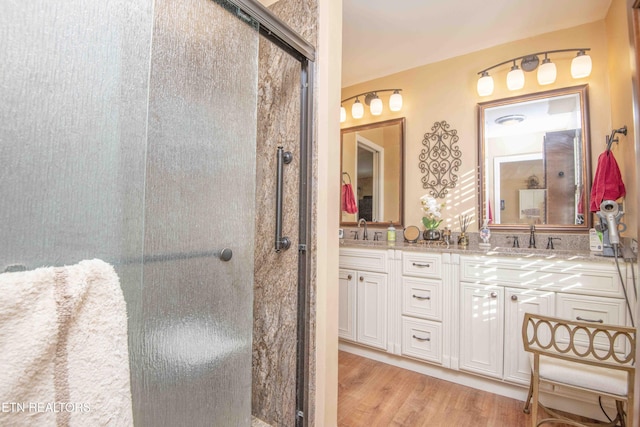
[342,0,620,87]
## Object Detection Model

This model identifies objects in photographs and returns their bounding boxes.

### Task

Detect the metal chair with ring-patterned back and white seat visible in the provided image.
[522,313,636,427]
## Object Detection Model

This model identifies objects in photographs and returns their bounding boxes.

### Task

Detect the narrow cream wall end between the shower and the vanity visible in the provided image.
[309,0,342,427]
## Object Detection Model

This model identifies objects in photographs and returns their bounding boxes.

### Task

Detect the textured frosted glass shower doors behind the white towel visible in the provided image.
[0,0,259,426]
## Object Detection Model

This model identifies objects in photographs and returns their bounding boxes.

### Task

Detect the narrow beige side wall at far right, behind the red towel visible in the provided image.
[605,1,638,238]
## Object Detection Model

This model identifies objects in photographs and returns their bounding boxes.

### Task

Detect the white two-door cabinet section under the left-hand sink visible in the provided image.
[338,248,389,350]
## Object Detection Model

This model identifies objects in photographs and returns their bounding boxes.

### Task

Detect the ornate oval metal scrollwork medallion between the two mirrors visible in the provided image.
[419,120,462,198]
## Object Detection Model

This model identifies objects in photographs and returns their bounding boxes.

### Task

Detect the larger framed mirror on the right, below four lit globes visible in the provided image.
[478,85,591,232]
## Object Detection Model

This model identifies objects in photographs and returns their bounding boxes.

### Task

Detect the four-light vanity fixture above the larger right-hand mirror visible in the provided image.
[477,48,592,96]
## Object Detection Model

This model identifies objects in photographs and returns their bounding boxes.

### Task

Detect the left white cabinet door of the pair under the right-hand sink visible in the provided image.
[460,283,504,378]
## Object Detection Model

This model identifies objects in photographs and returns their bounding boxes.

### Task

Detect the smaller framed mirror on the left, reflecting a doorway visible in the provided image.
[340,117,405,227]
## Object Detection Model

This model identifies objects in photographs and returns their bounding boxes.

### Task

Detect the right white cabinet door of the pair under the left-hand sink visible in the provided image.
[356,271,387,350]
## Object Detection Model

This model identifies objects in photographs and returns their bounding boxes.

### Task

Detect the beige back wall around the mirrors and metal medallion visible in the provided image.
[342,20,624,231]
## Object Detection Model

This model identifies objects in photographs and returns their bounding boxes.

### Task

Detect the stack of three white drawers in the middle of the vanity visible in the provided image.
[400,251,444,364]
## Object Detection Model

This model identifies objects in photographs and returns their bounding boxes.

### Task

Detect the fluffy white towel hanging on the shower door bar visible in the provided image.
[0,260,133,426]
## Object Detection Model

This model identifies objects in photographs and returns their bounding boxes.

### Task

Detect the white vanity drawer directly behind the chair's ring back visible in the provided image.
[556,293,627,352]
